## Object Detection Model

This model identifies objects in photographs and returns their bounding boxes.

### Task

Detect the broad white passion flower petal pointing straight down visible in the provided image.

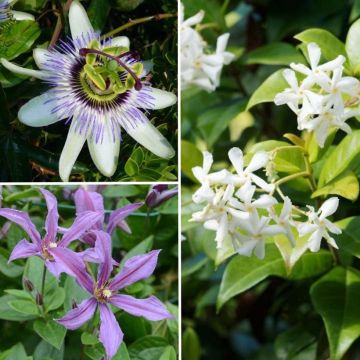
[87,122,120,177]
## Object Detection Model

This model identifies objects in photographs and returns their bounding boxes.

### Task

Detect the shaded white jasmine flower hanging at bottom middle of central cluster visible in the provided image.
[233,211,284,259]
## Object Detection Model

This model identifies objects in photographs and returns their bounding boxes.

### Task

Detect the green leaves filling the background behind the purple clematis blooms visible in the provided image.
[0,185,178,360]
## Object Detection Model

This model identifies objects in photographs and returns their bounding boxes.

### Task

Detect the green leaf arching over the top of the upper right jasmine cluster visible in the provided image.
[294,28,349,69]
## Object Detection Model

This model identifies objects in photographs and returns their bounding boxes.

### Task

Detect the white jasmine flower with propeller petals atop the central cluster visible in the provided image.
[228,148,274,197]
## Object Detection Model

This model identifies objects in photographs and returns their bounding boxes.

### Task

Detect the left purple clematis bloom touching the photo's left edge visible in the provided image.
[0,189,101,277]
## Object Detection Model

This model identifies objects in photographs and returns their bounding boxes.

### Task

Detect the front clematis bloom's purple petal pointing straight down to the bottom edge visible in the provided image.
[99,304,124,360]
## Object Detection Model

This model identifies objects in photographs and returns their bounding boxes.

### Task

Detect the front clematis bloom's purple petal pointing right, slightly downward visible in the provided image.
[110,295,173,321]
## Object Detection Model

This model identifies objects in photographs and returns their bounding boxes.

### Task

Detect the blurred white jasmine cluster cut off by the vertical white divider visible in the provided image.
[180,4,235,92]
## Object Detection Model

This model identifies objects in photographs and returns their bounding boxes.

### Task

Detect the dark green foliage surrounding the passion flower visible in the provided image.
[0,0,178,182]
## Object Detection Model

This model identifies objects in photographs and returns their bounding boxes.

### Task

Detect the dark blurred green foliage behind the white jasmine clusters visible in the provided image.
[181,0,360,360]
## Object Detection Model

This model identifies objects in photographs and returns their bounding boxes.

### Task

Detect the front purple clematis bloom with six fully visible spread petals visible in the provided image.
[53,231,173,360]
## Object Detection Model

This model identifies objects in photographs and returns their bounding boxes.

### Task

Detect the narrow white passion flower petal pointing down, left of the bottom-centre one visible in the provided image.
[59,119,86,182]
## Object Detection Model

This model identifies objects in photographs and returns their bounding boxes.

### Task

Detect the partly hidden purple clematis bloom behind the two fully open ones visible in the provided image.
[74,188,143,246]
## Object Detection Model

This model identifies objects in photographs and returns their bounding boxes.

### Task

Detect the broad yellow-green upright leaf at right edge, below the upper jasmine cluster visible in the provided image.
[319,130,360,187]
